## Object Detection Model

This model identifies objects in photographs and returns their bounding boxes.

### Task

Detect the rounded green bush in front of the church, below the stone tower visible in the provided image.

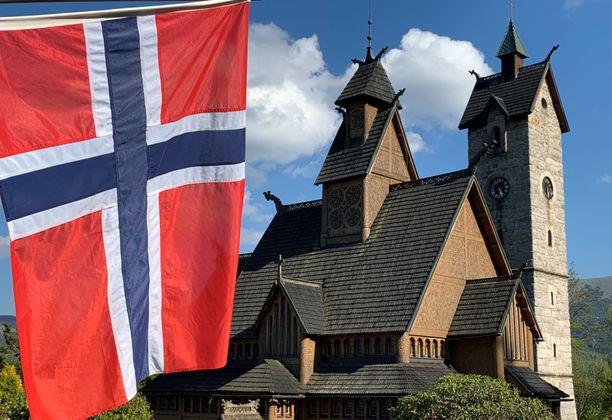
[391,374,554,420]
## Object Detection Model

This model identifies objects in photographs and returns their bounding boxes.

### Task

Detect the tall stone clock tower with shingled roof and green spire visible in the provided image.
[459,21,576,419]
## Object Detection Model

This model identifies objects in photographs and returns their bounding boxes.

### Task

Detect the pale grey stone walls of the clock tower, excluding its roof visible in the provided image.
[468,78,576,419]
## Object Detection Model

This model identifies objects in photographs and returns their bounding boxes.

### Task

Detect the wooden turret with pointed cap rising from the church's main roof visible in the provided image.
[315,47,417,246]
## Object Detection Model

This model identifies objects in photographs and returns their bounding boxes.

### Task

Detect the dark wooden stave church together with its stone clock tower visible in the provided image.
[144,21,576,420]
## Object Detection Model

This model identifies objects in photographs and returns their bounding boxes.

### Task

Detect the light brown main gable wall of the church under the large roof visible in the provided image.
[410,182,511,338]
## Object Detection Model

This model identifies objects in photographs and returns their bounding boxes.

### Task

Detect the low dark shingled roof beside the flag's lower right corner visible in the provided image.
[143,359,304,395]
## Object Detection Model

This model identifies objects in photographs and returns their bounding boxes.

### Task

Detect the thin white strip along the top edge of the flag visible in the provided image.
[0,0,251,31]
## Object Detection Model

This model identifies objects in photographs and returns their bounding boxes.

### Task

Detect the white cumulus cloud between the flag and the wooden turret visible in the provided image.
[247,24,348,164]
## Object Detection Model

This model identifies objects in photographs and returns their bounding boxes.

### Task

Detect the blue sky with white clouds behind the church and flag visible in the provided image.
[0,0,612,314]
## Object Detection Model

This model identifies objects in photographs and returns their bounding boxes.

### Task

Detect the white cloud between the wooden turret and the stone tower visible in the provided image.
[383,28,493,129]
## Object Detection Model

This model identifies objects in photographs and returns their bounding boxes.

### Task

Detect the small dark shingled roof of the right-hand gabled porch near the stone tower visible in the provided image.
[448,277,520,338]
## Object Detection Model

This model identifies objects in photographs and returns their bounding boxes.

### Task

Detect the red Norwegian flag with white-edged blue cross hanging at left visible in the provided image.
[0,1,248,419]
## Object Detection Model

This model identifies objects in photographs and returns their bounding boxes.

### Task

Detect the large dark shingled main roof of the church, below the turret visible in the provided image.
[232,171,475,337]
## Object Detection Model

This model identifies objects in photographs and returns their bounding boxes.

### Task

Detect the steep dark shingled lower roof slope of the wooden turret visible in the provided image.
[315,106,396,185]
